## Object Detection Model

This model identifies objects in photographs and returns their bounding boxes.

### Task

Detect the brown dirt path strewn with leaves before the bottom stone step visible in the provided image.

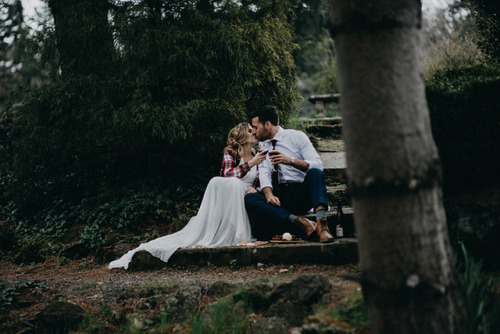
[0,258,359,330]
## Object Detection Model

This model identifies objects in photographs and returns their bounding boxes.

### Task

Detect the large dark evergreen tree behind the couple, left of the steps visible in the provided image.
[5,0,297,211]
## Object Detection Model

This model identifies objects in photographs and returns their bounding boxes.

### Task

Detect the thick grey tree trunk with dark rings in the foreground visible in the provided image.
[330,0,467,333]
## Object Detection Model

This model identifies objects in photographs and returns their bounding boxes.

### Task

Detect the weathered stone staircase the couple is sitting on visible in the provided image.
[129,120,358,270]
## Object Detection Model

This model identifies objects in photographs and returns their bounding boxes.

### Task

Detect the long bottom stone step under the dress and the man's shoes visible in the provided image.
[129,238,358,270]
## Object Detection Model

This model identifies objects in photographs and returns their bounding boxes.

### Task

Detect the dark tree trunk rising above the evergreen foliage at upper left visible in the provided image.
[49,0,114,78]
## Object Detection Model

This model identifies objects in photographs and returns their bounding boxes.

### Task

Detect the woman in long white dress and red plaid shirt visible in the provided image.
[109,123,266,269]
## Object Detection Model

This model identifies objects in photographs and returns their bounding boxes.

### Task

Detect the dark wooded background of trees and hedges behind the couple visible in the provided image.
[0,0,500,254]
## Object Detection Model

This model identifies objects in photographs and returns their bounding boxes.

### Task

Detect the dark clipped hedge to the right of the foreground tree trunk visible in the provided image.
[426,65,500,192]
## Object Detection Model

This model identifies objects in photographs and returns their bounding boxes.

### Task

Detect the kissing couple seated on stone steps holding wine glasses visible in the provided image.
[109,106,334,269]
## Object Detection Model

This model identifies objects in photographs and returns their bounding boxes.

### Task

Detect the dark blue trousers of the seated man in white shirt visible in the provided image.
[245,168,328,239]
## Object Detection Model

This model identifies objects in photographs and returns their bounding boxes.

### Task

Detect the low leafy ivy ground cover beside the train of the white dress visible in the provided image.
[11,181,204,251]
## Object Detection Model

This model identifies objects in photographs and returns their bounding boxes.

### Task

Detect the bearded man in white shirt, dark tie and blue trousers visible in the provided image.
[245,106,333,242]
